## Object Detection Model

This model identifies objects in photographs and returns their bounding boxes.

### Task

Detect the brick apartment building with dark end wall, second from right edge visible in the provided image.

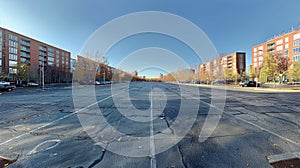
[199,52,246,81]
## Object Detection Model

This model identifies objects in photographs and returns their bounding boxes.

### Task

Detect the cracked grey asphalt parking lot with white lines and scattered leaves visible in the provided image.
[0,82,300,168]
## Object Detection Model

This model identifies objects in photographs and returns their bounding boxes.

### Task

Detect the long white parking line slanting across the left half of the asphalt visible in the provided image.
[0,92,123,146]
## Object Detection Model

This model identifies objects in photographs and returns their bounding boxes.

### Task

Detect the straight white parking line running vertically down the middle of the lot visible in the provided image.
[150,89,156,168]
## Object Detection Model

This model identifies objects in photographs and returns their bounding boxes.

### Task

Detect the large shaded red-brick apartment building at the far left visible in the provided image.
[0,27,71,83]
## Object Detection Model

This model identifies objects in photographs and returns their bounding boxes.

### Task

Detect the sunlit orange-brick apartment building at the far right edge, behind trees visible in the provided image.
[252,29,300,73]
